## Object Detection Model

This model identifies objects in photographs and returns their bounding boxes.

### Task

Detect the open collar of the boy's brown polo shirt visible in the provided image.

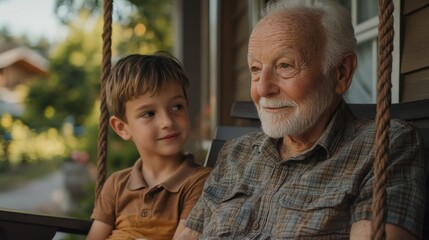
[127,154,198,192]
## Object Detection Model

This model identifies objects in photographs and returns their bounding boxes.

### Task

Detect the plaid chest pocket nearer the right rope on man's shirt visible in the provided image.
[274,190,353,239]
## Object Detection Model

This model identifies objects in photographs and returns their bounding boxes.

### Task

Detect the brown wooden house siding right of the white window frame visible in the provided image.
[400,0,429,102]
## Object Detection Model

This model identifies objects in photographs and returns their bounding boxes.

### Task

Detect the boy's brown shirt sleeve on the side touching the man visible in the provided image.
[180,167,211,219]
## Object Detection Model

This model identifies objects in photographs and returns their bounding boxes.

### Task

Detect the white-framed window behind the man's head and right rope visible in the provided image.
[339,0,400,103]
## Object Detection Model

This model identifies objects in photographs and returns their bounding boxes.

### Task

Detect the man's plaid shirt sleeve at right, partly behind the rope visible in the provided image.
[352,121,426,237]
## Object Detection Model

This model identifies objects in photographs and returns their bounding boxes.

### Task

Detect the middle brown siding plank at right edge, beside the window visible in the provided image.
[401,6,429,74]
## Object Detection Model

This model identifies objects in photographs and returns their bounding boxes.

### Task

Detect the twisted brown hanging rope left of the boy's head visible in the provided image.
[95,0,113,200]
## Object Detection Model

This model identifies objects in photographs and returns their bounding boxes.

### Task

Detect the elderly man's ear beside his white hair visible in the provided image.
[335,52,357,95]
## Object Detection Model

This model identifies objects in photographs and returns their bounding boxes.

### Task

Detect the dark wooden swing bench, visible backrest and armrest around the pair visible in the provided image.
[0,99,429,240]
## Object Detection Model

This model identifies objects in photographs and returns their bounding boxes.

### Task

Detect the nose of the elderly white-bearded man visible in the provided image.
[258,66,280,97]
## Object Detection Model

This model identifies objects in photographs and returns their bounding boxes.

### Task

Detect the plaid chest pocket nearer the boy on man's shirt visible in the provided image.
[203,183,254,237]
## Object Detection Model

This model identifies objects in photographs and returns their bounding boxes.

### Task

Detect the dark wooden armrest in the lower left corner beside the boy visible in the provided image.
[0,209,92,240]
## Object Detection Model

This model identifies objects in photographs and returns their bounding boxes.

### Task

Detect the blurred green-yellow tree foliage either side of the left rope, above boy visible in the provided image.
[23,0,172,130]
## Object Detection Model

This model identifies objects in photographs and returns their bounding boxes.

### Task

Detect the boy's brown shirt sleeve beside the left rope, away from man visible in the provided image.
[91,172,116,227]
